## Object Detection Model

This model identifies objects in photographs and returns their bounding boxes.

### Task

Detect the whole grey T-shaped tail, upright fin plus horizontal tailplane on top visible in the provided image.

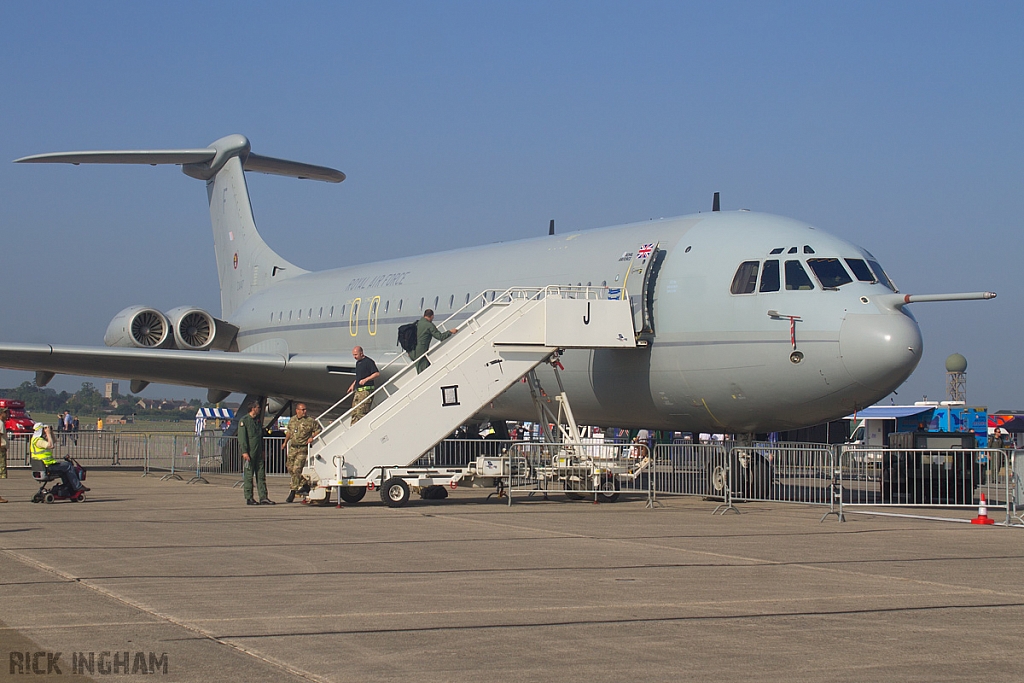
[15,135,345,318]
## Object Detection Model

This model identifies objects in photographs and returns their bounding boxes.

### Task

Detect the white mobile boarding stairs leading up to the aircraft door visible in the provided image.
[306,286,636,499]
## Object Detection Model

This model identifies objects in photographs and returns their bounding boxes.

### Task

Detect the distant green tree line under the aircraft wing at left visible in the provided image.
[0,382,212,419]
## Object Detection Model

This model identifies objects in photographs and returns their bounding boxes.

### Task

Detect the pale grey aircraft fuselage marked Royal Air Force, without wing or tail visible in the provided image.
[229,212,923,432]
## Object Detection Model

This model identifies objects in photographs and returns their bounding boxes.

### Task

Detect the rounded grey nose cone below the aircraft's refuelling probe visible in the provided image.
[839,313,924,393]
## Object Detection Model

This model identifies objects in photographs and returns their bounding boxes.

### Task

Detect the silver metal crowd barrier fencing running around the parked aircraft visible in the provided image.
[7,431,1024,524]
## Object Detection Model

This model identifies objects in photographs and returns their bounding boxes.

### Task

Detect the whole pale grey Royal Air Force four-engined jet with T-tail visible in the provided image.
[0,135,995,434]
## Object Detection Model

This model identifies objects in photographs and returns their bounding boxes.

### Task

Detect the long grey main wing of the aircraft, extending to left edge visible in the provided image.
[0,344,354,403]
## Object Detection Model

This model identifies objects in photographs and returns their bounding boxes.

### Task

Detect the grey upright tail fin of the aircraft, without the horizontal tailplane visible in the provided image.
[206,157,306,318]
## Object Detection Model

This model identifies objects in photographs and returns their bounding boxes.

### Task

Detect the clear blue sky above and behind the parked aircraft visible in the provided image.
[0,2,1024,410]
